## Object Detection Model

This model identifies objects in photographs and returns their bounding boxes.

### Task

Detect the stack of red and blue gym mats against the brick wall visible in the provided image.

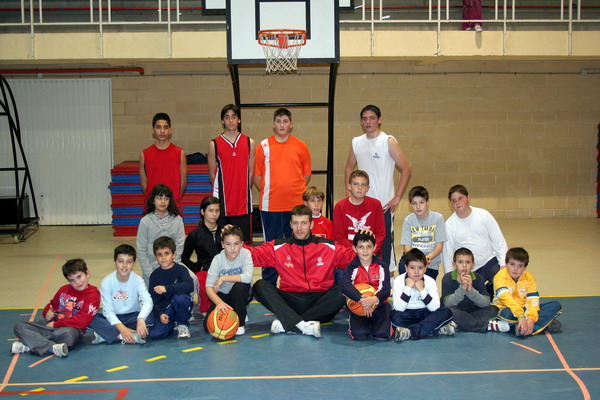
[109,161,212,236]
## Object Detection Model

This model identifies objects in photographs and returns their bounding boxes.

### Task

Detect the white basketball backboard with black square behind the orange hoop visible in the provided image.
[226,0,340,64]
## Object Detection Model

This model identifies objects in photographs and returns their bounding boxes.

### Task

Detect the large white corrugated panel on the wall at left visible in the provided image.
[0,79,113,225]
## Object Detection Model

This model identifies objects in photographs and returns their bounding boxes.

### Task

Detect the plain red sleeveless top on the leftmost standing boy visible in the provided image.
[144,143,183,212]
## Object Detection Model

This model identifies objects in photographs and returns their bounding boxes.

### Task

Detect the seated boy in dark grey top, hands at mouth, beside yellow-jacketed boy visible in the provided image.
[442,247,508,332]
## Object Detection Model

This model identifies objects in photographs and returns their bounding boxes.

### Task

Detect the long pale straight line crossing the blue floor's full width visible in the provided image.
[6,367,600,386]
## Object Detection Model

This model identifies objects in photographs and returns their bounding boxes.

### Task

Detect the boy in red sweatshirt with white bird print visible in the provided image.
[333,170,386,255]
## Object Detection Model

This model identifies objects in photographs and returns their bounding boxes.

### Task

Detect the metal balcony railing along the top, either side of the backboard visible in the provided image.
[0,0,600,58]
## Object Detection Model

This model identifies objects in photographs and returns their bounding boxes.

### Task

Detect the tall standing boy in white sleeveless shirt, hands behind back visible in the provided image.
[345,104,411,270]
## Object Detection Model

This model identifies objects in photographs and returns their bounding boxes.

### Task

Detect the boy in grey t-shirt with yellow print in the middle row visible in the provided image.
[398,186,446,280]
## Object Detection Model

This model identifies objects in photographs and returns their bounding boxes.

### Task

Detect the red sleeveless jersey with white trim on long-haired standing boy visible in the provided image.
[213,133,252,217]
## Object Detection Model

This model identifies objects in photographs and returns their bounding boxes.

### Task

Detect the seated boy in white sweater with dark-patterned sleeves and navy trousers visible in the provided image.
[390,249,456,342]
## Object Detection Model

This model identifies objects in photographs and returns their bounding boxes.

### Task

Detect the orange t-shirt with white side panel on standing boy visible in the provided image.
[254,135,312,212]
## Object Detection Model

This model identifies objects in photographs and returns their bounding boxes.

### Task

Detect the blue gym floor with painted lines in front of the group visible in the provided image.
[0,296,600,400]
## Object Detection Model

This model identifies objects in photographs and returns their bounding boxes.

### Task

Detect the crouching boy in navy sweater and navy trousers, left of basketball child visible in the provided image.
[148,236,194,339]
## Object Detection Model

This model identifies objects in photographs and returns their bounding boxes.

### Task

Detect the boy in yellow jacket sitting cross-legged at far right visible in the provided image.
[494,247,562,336]
